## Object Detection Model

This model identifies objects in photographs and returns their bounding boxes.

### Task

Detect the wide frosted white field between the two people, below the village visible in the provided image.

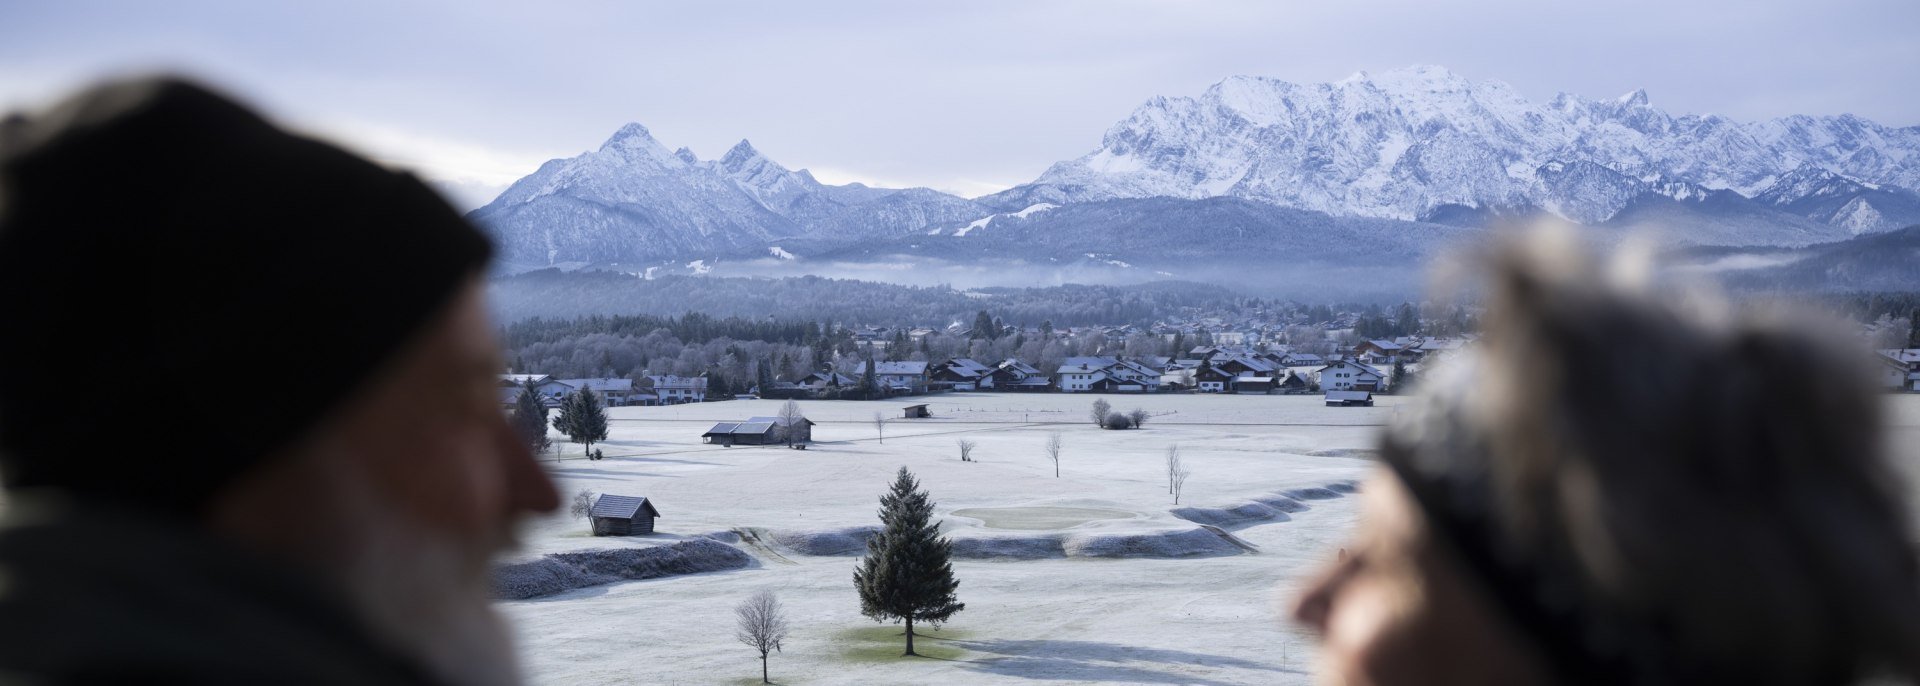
[501,394,1920,684]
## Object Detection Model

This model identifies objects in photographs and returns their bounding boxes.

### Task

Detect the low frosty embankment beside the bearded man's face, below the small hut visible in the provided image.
[493,538,753,600]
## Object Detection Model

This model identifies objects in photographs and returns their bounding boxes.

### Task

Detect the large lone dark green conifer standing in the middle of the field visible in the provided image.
[852,467,966,655]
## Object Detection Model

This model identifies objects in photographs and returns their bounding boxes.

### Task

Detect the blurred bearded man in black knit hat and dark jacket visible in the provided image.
[0,81,557,684]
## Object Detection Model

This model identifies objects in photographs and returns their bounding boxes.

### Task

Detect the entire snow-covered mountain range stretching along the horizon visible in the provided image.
[470,67,1920,271]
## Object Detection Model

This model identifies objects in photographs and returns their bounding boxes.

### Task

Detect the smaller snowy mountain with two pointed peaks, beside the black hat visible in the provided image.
[468,123,991,271]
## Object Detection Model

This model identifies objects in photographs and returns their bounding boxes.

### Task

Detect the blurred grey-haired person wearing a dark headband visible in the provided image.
[1296,234,1920,686]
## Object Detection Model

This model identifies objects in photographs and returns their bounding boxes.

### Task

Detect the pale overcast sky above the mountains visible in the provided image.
[0,0,1920,208]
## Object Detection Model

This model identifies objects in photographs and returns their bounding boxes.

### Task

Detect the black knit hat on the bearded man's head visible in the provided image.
[0,79,492,515]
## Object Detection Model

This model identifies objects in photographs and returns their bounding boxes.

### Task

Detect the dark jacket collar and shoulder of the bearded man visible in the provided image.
[0,502,432,686]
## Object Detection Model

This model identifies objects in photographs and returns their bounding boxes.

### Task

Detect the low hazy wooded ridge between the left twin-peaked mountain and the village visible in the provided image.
[488,269,1254,327]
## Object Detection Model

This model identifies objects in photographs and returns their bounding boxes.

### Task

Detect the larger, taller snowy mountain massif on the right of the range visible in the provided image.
[979,67,1920,242]
